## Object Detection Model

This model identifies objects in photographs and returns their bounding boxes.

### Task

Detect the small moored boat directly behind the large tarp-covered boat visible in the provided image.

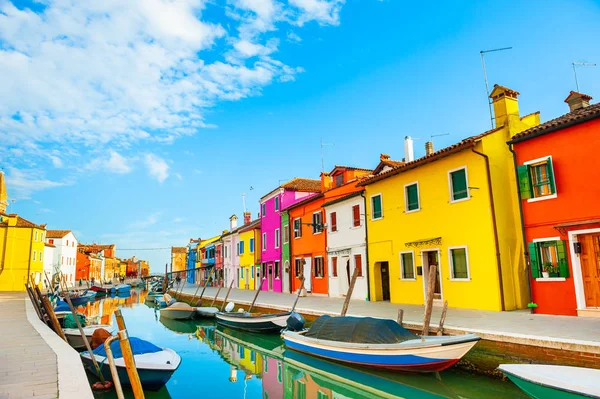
[215,312,292,334]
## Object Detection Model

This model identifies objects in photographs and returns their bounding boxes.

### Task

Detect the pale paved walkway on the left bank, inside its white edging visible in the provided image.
[0,292,58,399]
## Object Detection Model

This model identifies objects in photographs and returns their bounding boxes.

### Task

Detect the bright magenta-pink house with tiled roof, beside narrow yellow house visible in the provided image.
[257,178,321,292]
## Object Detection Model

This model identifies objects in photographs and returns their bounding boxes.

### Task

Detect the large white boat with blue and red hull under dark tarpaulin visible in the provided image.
[281,316,480,372]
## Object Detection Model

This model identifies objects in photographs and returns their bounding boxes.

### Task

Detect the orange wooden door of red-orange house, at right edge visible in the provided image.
[578,234,600,308]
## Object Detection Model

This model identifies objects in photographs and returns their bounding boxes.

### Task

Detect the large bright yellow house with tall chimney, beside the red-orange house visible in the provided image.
[359,85,539,311]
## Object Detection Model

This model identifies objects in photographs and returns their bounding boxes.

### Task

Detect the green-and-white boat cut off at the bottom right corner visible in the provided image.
[498,364,600,399]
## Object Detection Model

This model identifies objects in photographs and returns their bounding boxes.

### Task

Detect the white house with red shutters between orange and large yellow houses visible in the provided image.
[323,191,369,300]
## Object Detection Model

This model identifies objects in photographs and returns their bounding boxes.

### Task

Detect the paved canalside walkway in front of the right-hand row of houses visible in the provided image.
[177,286,600,353]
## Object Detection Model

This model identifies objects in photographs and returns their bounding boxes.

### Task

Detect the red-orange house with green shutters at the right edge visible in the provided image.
[509,92,600,317]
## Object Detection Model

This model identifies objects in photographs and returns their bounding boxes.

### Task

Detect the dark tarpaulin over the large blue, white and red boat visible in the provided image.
[304,315,417,344]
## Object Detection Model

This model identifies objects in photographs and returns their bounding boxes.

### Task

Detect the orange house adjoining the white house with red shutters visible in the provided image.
[285,166,372,295]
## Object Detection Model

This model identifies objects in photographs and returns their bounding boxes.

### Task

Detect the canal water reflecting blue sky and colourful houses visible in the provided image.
[79,291,526,399]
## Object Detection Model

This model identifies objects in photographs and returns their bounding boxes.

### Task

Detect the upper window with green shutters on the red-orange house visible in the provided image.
[517,157,556,199]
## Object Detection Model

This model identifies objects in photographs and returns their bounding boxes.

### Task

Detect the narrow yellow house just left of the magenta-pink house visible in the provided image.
[235,219,260,290]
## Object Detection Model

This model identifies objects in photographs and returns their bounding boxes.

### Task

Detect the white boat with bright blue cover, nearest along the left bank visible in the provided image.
[80,337,181,391]
